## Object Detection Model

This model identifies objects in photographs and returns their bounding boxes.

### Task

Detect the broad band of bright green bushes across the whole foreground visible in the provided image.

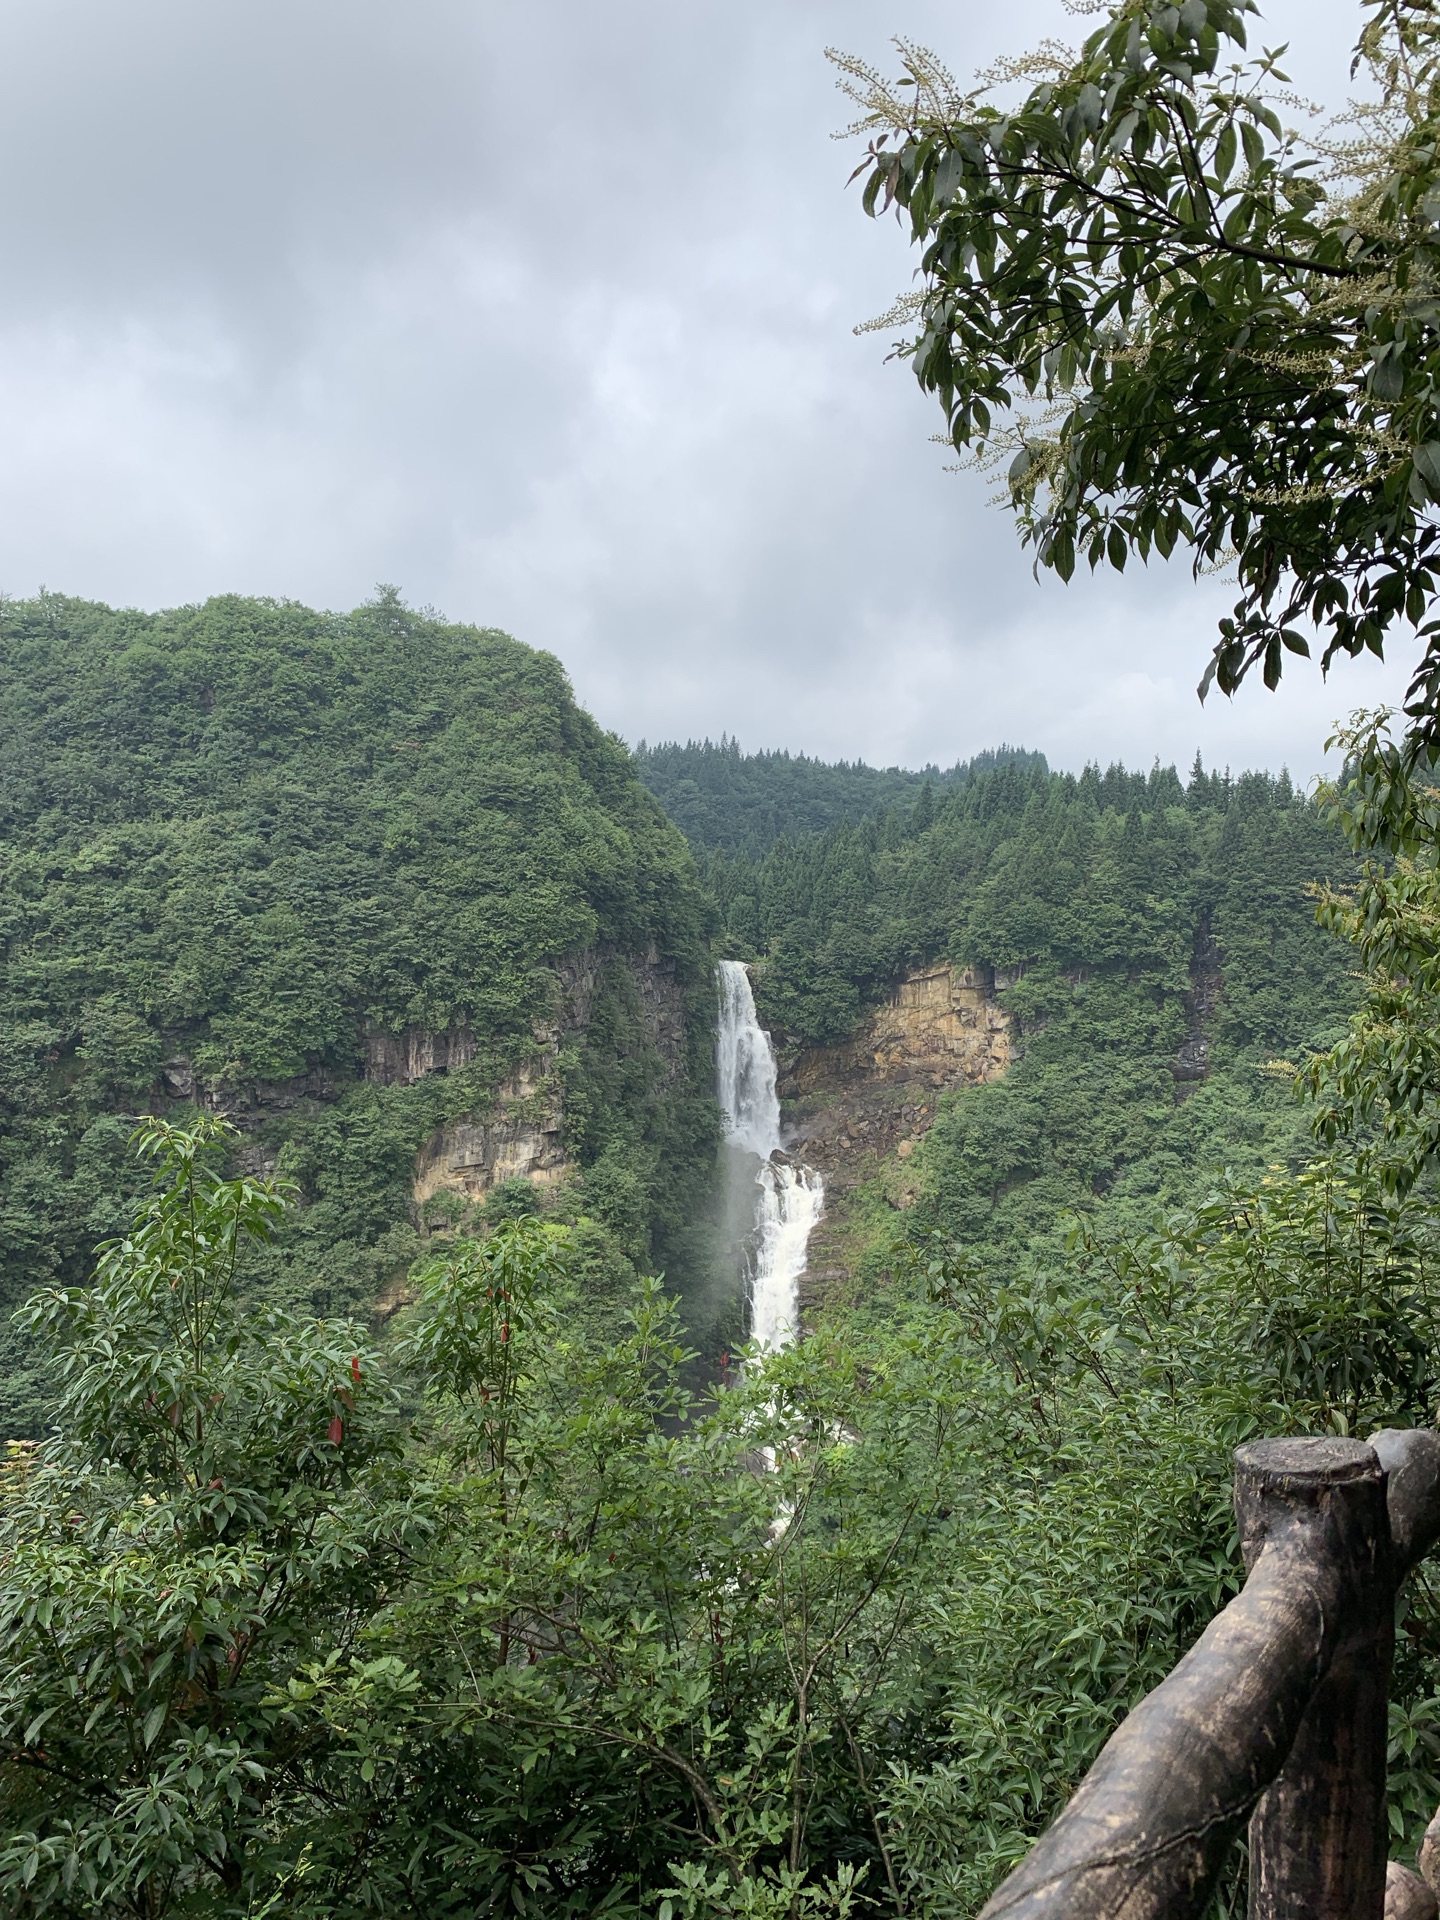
[0,1123,1440,1920]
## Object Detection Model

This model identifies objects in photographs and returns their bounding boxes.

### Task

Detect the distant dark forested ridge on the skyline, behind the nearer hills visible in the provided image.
[636,735,1044,858]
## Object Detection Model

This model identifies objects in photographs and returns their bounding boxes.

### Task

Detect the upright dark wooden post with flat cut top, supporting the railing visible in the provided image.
[1235,1440,1396,1920]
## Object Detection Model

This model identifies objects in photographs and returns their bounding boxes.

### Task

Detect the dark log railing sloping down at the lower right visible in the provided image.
[981,1428,1440,1920]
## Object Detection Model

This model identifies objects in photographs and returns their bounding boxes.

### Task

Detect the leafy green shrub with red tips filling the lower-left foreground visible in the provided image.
[0,1121,424,1914]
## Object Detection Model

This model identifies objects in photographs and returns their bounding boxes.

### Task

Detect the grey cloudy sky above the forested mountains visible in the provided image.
[0,0,1405,774]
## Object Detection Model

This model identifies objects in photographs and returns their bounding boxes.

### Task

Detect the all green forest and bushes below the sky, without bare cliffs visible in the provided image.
[0,595,1440,1920]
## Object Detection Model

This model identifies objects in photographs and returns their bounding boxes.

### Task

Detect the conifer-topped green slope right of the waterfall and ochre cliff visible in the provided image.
[699,762,1356,1277]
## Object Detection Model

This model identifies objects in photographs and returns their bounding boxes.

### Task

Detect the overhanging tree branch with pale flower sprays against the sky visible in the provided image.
[835,0,1440,739]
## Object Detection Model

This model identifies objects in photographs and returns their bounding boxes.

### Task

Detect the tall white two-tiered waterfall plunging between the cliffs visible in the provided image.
[716,960,826,1354]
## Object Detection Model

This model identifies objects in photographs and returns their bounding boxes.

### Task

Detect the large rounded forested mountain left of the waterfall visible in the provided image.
[0,593,714,1432]
